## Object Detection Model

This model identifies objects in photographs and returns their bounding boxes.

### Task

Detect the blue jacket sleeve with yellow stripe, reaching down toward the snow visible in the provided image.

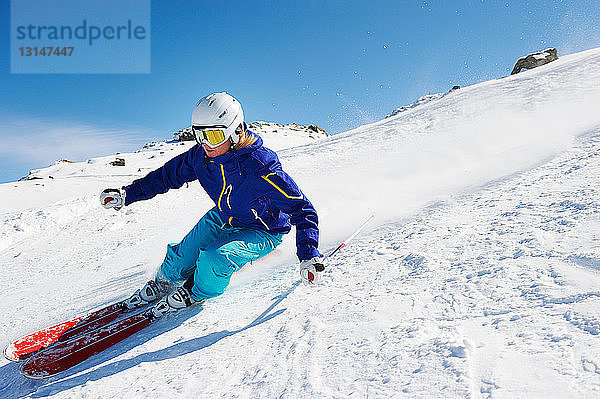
[260,168,321,261]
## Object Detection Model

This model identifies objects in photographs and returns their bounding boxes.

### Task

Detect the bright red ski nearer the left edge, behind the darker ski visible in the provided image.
[4,302,125,362]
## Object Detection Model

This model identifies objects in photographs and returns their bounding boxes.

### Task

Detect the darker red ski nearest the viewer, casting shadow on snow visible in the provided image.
[21,310,155,379]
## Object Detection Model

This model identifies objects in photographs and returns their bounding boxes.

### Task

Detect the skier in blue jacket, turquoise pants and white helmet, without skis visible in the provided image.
[100,92,324,317]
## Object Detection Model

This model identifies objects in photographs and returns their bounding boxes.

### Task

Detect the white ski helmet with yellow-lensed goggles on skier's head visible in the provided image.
[192,92,244,147]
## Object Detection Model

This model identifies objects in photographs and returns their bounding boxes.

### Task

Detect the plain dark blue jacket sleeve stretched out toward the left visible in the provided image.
[123,146,196,205]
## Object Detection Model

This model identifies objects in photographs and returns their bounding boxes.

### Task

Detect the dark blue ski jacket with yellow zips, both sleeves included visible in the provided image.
[123,132,321,260]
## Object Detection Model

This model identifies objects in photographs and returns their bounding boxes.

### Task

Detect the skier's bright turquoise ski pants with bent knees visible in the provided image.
[157,208,283,301]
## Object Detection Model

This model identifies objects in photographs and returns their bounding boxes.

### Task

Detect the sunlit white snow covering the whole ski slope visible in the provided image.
[0,49,600,398]
